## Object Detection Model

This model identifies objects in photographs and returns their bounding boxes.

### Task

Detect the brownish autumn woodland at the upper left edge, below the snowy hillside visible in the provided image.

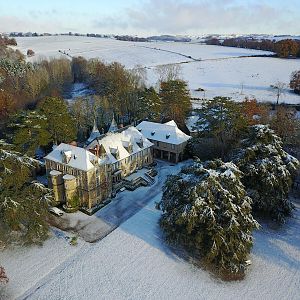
[0,39,73,125]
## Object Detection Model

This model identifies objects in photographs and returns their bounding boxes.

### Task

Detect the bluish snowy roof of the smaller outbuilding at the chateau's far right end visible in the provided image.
[136,120,191,145]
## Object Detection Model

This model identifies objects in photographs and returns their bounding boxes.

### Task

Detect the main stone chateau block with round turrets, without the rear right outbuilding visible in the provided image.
[45,127,153,213]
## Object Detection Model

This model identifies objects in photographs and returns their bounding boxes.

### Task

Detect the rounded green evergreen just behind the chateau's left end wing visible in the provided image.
[39,97,77,144]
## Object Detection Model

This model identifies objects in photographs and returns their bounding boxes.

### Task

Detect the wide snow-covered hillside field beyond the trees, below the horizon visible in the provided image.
[17,36,300,103]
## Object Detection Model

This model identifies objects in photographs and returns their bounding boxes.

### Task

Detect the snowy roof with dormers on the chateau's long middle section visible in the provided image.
[86,126,153,163]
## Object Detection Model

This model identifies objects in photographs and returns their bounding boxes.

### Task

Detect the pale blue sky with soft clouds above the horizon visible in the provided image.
[0,0,300,36]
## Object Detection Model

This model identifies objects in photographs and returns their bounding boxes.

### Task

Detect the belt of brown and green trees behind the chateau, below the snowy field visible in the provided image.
[71,57,191,139]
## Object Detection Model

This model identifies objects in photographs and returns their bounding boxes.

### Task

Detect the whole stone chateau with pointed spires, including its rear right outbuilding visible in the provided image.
[45,119,190,214]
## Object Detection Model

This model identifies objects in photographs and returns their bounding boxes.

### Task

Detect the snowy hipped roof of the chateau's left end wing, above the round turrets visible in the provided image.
[45,143,97,171]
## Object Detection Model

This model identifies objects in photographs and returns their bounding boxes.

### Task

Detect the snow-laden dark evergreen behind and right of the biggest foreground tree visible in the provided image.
[234,125,299,222]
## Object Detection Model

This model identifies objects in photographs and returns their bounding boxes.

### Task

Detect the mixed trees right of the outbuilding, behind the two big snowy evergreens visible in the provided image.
[189,97,300,160]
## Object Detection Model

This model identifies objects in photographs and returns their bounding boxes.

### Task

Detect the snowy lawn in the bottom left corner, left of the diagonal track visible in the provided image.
[0,229,87,300]
